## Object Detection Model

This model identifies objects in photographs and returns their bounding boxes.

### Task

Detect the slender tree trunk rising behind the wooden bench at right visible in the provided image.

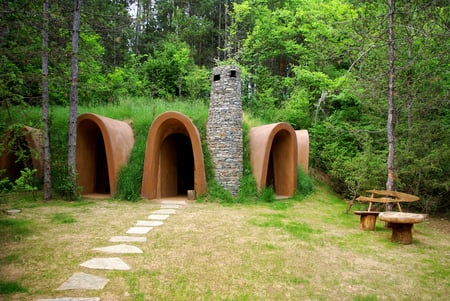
[386,0,395,210]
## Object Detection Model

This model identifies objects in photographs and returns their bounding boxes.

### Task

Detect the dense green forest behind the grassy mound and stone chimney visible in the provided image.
[0,0,450,213]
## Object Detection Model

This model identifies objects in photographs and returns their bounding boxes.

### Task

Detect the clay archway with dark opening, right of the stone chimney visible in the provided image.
[249,122,297,196]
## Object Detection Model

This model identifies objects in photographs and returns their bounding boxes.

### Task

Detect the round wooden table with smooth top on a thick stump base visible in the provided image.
[379,212,427,244]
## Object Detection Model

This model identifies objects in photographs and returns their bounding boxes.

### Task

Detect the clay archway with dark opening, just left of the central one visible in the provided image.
[76,113,134,195]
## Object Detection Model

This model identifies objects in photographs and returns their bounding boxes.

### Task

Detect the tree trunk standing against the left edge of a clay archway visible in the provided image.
[67,0,81,198]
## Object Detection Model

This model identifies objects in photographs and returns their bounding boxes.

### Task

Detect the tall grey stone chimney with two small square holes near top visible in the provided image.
[206,66,243,196]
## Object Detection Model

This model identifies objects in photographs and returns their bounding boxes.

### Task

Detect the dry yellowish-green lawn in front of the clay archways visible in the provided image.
[0,187,450,301]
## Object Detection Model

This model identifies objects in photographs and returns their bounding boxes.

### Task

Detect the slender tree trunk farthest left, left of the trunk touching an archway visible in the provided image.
[42,0,52,200]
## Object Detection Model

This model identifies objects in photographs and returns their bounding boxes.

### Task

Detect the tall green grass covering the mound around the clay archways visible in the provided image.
[0,97,312,203]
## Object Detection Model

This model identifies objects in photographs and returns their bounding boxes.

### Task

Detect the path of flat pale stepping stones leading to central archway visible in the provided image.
[37,200,186,301]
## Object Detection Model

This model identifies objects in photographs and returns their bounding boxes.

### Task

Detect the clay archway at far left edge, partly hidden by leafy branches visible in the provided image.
[0,126,43,181]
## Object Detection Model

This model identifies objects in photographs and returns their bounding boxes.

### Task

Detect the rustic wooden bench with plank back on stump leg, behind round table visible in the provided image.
[354,189,419,231]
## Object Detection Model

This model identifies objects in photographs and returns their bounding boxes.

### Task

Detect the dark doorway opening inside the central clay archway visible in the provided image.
[159,134,195,197]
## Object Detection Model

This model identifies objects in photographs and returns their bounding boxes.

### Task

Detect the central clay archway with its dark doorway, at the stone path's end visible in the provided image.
[141,112,206,199]
